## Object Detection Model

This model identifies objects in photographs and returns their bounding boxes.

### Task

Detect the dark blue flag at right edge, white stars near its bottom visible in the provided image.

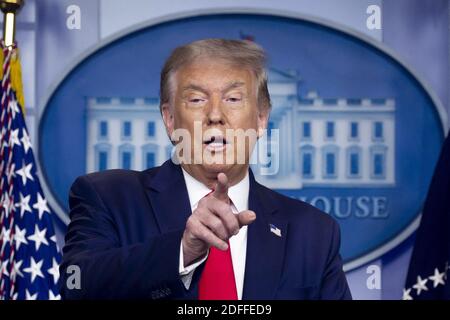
[403,129,450,300]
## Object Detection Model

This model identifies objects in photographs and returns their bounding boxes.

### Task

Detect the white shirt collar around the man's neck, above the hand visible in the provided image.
[181,168,250,212]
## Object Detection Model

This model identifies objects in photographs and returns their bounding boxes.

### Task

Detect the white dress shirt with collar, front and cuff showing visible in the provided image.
[179,169,250,300]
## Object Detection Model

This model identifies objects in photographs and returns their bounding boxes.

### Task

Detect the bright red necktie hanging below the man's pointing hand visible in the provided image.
[198,192,238,300]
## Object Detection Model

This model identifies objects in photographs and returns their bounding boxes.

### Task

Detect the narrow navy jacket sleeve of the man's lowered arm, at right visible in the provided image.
[320,220,352,300]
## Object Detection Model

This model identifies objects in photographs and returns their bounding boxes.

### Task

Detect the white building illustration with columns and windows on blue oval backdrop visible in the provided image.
[86,69,395,189]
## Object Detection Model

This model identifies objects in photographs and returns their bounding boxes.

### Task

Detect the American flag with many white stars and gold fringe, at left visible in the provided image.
[0,42,61,300]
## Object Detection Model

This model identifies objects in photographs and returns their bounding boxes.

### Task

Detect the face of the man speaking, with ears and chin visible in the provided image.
[163,59,268,182]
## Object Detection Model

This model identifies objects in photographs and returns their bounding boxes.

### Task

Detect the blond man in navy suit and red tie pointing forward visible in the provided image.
[60,39,351,299]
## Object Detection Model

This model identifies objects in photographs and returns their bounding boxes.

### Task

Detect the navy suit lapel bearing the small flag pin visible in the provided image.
[242,172,288,300]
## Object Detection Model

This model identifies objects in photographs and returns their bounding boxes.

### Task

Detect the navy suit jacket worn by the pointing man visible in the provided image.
[60,160,351,299]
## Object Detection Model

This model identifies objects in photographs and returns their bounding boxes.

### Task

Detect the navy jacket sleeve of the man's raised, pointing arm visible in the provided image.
[59,176,192,299]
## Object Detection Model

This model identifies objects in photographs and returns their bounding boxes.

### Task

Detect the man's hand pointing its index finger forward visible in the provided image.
[182,173,256,267]
